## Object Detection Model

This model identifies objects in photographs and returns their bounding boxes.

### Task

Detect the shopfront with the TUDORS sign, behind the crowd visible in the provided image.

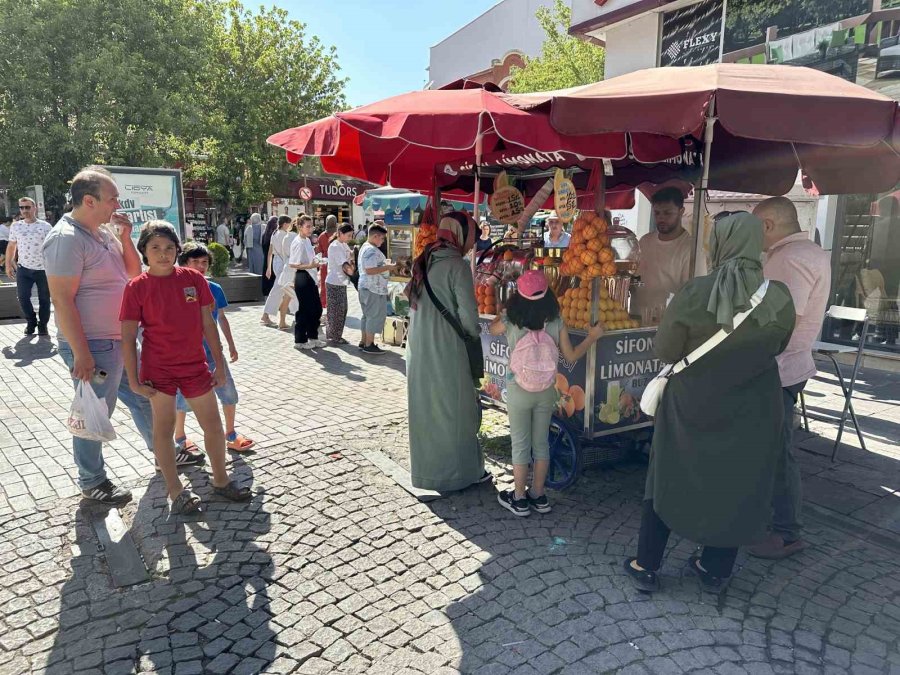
[269,176,376,229]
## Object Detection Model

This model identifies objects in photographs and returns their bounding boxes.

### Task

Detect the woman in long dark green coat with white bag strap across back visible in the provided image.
[625,213,795,592]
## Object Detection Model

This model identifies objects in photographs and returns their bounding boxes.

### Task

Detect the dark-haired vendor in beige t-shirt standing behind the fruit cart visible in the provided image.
[634,187,706,314]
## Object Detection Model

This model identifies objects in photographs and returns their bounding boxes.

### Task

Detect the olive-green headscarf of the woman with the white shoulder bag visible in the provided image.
[706,212,781,331]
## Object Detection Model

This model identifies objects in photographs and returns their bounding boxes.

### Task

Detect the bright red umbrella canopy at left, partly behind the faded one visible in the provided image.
[267,88,640,191]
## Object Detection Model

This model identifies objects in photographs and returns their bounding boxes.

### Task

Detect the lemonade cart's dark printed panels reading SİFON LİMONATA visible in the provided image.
[479,315,663,438]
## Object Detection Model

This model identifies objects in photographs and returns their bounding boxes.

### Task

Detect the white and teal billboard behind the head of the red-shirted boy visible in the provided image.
[106,166,185,241]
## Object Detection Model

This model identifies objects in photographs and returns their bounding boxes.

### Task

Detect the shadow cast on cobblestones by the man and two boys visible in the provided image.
[47,458,276,675]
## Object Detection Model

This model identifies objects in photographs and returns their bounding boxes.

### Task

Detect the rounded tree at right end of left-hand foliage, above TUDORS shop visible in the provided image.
[178,0,346,209]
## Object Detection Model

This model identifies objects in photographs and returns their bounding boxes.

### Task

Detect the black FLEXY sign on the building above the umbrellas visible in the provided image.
[659,0,725,66]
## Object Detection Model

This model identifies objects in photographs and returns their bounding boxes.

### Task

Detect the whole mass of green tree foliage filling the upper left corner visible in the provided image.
[0,0,345,213]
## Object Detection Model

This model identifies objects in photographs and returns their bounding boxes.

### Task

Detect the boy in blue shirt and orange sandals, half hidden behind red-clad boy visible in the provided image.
[175,241,254,452]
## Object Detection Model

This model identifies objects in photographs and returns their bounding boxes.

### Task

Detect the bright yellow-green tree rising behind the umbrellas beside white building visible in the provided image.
[509,0,606,94]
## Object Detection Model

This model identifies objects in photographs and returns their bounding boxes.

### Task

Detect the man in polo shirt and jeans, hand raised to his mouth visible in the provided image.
[43,167,165,504]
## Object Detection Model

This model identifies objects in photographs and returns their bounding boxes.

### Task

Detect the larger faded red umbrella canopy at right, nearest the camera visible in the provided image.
[503,64,900,194]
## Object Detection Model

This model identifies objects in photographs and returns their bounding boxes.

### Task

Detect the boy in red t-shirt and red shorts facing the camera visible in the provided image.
[119,220,251,513]
